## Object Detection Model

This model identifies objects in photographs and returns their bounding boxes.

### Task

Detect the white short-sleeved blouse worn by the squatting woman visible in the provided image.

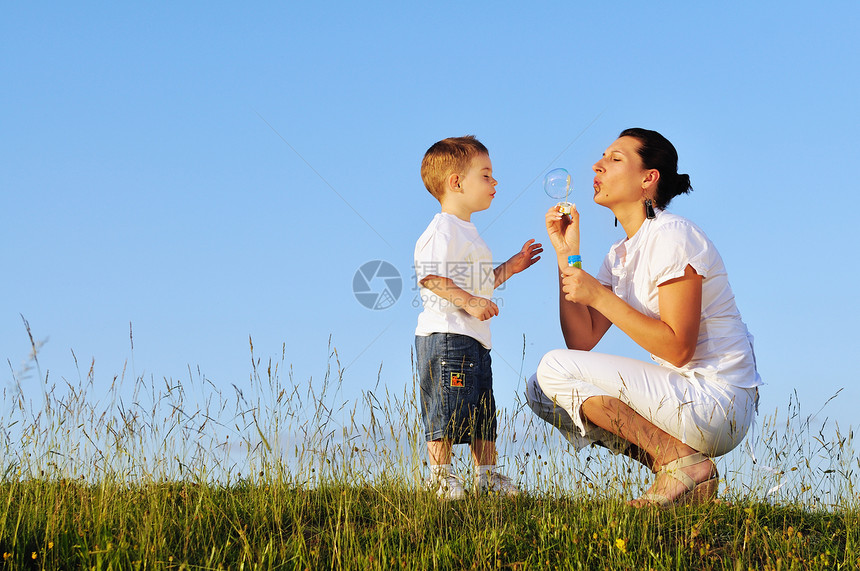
[597,211,762,388]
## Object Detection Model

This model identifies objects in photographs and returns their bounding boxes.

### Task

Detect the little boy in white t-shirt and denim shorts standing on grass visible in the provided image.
[415,136,543,499]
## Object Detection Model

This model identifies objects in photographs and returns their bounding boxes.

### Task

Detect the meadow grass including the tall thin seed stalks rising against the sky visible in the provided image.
[0,324,860,570]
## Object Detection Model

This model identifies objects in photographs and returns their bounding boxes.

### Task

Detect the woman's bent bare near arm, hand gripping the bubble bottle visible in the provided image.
[562,265,702,367]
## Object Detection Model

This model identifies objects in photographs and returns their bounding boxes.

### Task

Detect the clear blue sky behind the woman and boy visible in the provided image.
[0,1,860,442]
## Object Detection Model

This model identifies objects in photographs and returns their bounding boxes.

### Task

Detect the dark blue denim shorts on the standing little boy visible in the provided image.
[415,333,496,444]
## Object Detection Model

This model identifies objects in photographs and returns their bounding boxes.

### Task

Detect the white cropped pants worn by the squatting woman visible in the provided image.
[526,349,758,457]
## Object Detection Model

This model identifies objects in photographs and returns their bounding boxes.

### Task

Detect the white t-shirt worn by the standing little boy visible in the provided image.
[415,212,496,349]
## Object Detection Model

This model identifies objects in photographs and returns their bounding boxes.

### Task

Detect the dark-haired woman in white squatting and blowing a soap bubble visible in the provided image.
[527,129,762,506]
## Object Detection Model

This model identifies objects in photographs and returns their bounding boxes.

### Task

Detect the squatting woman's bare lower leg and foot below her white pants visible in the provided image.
[581,396,716,500]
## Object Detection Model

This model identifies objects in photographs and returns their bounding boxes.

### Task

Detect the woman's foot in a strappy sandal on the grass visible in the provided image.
[629,452,719,507]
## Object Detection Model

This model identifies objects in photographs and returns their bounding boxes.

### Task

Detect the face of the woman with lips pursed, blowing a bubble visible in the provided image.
[591,137,648,207]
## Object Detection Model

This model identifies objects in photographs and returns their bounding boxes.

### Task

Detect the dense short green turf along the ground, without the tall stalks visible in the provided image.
[0,480,860,569]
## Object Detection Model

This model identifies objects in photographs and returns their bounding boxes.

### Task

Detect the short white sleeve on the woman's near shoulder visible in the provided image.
[649,221,713,286]
